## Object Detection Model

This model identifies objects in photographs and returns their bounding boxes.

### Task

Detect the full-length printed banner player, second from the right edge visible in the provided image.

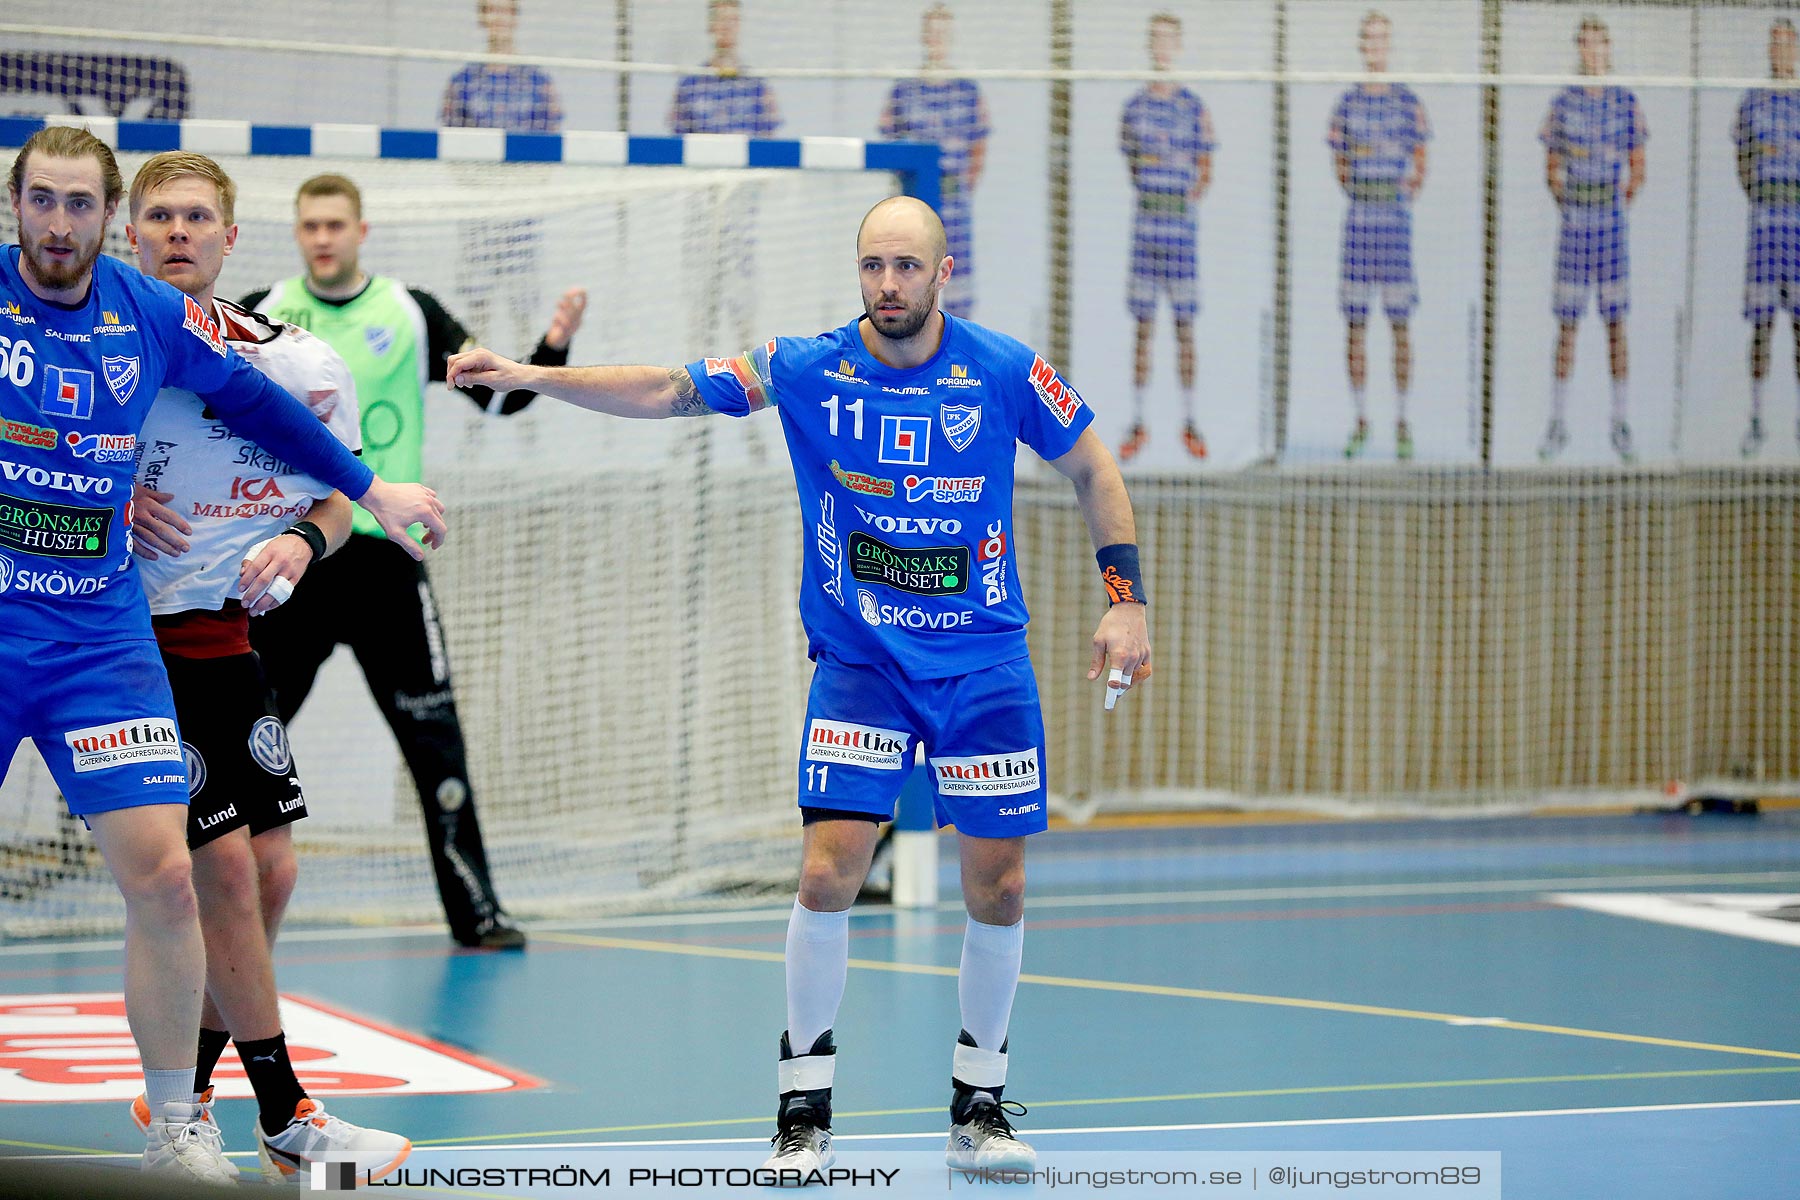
[1537,16,1649,462]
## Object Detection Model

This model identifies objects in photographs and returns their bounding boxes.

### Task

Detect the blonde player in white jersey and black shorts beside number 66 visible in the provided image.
[126,151,412,1182]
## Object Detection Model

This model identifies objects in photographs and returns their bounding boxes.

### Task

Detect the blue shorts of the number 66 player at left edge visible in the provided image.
[0,637,187,817]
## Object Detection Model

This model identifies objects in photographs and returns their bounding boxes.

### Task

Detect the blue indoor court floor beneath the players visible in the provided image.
[0,811,1800,1200]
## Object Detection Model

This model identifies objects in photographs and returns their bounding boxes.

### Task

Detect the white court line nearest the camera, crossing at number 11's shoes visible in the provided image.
[14,1097,1800,1162]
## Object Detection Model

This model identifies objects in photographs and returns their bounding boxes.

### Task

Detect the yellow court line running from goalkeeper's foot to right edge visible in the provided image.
[538,932,1800,1061]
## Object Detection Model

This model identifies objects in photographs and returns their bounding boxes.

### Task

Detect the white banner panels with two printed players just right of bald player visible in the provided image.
[1075,0,1481,475]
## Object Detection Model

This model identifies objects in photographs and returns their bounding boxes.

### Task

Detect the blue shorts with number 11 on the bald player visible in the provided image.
[799,655,1049,838]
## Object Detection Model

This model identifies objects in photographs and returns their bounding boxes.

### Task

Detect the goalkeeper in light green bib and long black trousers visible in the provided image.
[243,175,587,948]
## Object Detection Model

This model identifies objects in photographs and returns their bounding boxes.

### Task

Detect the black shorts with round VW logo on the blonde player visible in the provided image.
[162,653,306,849]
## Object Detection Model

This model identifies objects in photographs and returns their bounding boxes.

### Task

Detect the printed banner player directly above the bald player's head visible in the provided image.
[882,4,988,317]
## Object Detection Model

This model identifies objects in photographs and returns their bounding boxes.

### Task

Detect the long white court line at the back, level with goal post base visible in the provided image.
[0,871,1800,957]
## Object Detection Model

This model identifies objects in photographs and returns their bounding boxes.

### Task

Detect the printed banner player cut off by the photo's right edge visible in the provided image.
[1732,16,1800,459]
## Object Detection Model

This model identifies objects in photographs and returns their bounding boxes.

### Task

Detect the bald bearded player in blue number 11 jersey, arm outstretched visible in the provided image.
[448,196,1150,1178]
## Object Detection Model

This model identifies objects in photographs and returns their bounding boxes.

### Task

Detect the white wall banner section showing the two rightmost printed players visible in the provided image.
[1494,4,1800,466]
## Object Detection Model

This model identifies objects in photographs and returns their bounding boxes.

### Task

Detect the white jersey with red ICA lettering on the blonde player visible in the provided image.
[137,300,362,615]
